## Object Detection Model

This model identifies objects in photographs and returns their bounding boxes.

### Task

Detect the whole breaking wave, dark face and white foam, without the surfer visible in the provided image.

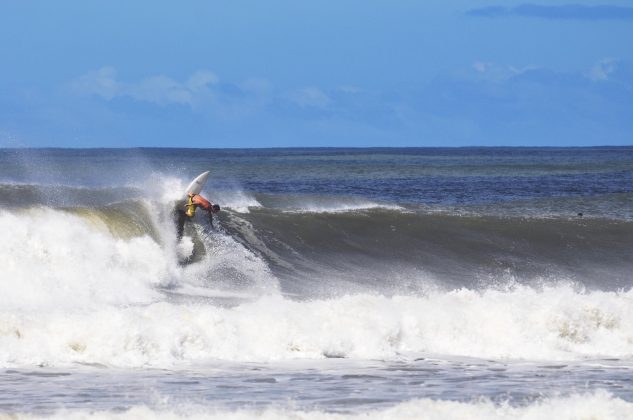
[0,177,633,367]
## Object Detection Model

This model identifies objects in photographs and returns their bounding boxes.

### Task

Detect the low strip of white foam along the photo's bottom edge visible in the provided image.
[8,391,633,420]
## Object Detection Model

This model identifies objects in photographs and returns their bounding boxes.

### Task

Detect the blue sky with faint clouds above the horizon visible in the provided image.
[0,0,633,148]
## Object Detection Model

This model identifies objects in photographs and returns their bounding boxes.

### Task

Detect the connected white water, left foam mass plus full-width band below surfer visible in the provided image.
[0,205,633,367]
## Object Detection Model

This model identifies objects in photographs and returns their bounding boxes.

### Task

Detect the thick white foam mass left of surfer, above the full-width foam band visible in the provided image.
[0,208,169,312]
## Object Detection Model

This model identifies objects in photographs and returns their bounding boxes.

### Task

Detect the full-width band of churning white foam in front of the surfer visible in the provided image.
[0,286,633,367]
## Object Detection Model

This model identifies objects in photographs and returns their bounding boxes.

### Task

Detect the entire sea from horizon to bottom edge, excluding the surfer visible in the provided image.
[0,147,633,419]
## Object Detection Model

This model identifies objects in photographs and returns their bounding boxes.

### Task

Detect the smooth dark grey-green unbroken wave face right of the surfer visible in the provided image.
[224,209,633,292]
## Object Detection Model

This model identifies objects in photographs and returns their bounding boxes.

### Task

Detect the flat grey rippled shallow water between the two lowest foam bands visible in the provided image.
[7,358,633,415]
